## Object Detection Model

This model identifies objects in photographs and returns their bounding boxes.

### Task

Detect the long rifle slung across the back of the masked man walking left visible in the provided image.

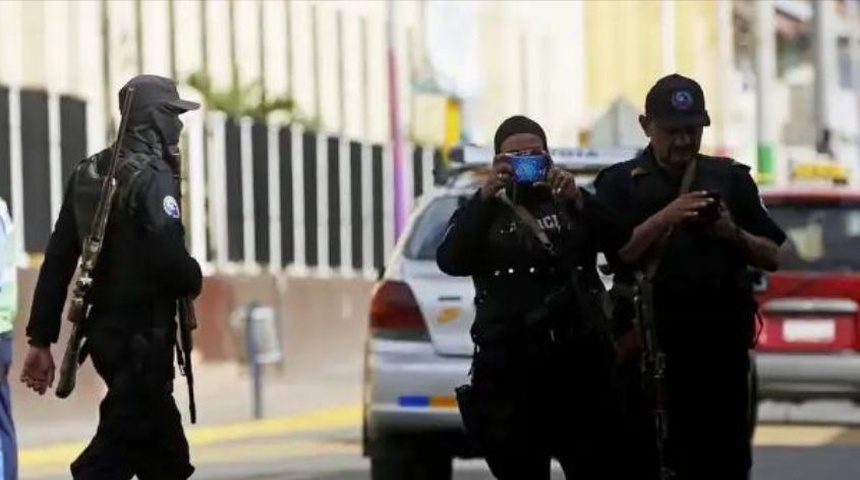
[55,87,135,398]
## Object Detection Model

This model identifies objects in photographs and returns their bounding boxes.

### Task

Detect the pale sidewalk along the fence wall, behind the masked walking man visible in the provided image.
[12,346,361,451]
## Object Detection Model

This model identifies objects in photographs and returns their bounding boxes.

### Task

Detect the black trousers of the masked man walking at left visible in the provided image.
[71,312,194,480]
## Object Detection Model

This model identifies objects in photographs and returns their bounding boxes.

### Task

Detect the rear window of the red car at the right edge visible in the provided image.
[768,200,860,272]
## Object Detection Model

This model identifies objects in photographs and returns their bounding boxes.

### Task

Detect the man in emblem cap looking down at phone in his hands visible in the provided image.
[595,74,785,480]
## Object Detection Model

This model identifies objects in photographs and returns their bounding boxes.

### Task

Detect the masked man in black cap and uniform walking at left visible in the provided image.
[22,75,202,480]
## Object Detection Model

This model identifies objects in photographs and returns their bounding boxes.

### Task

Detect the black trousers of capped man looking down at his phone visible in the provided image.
[619,345,754,480]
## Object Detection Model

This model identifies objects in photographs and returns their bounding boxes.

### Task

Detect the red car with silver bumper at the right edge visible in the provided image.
[756,186,860,402]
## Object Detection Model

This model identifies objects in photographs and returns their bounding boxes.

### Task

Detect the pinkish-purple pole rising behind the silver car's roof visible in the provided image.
[385,0,407,239]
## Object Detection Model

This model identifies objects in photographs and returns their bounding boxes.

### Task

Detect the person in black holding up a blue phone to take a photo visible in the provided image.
[437,116,630,480]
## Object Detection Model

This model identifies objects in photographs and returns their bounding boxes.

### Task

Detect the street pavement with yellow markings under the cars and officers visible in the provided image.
[22,404,860,480]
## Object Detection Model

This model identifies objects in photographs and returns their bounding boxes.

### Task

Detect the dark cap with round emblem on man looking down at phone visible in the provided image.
[645,73,711,127]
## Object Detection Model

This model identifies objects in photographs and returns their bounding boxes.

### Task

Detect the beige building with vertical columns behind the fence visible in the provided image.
[0,0,596,148]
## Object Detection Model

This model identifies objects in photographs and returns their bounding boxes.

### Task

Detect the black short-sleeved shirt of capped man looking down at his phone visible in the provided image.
[595,148,786,344]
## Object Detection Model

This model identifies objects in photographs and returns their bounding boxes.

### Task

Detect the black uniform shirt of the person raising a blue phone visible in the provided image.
[436,186,629,344]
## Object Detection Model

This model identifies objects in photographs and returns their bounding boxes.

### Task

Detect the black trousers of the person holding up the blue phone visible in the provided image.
[470,337,620,480]
